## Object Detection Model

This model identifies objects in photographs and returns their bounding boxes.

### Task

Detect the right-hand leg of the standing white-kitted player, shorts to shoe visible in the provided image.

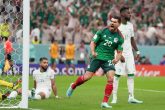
[126,55,143,103]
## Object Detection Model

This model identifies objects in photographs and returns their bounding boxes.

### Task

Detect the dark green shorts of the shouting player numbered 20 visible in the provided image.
[87,59,115,73]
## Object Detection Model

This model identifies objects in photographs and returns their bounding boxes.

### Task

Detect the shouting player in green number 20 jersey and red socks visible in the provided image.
[66,16,124,108]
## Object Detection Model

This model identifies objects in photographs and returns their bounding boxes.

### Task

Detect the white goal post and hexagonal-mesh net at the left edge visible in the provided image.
[0,0,30,108]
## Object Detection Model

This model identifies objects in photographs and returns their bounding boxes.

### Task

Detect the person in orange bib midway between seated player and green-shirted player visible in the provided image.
[65,39,76,75]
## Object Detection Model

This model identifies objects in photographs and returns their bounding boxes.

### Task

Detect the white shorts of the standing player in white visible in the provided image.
[115,55,136,75]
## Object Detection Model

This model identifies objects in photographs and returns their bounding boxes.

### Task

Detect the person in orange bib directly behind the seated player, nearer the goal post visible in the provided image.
[49,40,59,70]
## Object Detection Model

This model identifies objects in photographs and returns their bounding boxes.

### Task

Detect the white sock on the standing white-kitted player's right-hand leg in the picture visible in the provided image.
[127,77,134,98]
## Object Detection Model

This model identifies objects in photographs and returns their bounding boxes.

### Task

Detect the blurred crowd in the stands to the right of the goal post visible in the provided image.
[30,0,165,45]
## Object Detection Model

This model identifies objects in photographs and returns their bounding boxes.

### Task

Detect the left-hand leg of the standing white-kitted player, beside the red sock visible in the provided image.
[111,62,125,104]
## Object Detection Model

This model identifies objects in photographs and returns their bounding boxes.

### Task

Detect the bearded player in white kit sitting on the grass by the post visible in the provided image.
[8,57,59,99]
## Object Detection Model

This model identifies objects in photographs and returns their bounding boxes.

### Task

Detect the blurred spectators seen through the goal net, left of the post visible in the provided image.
[0,0,23,43]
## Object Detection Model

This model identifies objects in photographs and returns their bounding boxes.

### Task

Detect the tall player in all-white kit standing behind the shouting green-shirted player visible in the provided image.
[111,6,143,103]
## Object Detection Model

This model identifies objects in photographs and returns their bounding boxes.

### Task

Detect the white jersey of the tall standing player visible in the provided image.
[119,22,134,56]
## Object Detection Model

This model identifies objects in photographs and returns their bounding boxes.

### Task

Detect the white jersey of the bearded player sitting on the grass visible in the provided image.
[33,68,55,89]
